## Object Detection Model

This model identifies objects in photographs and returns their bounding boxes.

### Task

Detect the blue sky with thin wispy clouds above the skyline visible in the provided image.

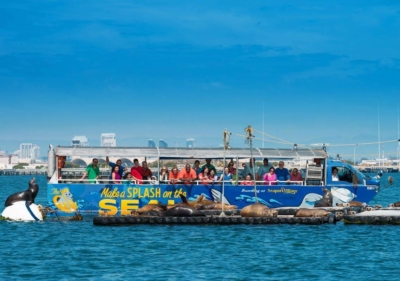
[0,0,400,159]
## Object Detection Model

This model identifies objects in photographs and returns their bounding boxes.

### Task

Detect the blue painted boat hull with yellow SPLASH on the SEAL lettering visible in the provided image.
[47,184,378,215]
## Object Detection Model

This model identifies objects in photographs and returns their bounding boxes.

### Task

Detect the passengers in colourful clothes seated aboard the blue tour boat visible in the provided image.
[82,156,306,185]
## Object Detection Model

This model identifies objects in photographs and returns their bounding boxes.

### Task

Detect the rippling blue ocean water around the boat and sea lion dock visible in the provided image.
[0,174,400,280]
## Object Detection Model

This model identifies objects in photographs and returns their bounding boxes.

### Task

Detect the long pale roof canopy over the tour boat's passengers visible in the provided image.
[55,146,327,159]
